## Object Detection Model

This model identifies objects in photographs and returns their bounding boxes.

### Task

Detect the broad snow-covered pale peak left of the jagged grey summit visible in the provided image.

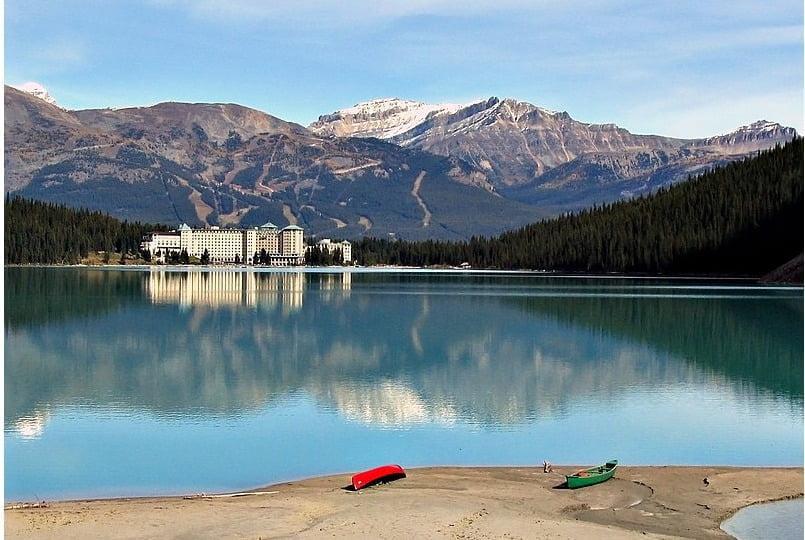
[310,98,480,139]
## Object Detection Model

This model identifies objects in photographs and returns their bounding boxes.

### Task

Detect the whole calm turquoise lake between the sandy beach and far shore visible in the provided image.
[4,268,803,500]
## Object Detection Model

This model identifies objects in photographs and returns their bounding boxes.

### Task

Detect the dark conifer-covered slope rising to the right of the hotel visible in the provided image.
[353,138,803,275]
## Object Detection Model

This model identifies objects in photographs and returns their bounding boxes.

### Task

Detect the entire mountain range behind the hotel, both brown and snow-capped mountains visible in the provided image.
[5,86,796,239]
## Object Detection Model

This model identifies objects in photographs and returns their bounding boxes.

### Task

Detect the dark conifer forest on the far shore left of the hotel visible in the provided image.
[4,197,165,264]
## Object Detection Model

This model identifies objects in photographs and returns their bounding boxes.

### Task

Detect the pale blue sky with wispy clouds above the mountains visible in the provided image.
[5,0,803,137]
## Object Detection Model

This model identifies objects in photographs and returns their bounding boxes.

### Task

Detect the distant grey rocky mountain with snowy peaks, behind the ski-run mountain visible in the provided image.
[310,97,796,202]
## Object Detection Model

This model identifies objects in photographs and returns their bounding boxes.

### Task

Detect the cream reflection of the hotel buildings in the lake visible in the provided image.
[144,270,352,313]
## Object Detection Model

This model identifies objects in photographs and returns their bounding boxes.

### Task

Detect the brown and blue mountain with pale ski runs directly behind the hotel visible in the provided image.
[5,87,545,239]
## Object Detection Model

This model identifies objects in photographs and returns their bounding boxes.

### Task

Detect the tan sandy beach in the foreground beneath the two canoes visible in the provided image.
[5,467,803,539]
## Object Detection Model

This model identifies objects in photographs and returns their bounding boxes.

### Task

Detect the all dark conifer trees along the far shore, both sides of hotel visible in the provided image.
[5,138,803,275]
